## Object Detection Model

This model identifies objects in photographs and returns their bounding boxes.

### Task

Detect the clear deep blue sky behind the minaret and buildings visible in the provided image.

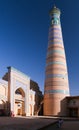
[0,0,79,95]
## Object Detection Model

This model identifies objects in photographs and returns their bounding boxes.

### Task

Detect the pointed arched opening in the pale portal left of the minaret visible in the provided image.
[14,88,25,116]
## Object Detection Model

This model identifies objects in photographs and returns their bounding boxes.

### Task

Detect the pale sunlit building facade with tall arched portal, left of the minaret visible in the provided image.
[0,67,42,116]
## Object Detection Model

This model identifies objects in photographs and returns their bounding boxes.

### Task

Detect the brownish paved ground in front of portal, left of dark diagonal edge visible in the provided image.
[0,117,55,130]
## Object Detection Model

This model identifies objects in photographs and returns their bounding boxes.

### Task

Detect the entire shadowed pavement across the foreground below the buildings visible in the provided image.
[0,117,79,130]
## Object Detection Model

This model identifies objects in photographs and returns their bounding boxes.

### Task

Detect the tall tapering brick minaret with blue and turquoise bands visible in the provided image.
[44,7,69,116]
